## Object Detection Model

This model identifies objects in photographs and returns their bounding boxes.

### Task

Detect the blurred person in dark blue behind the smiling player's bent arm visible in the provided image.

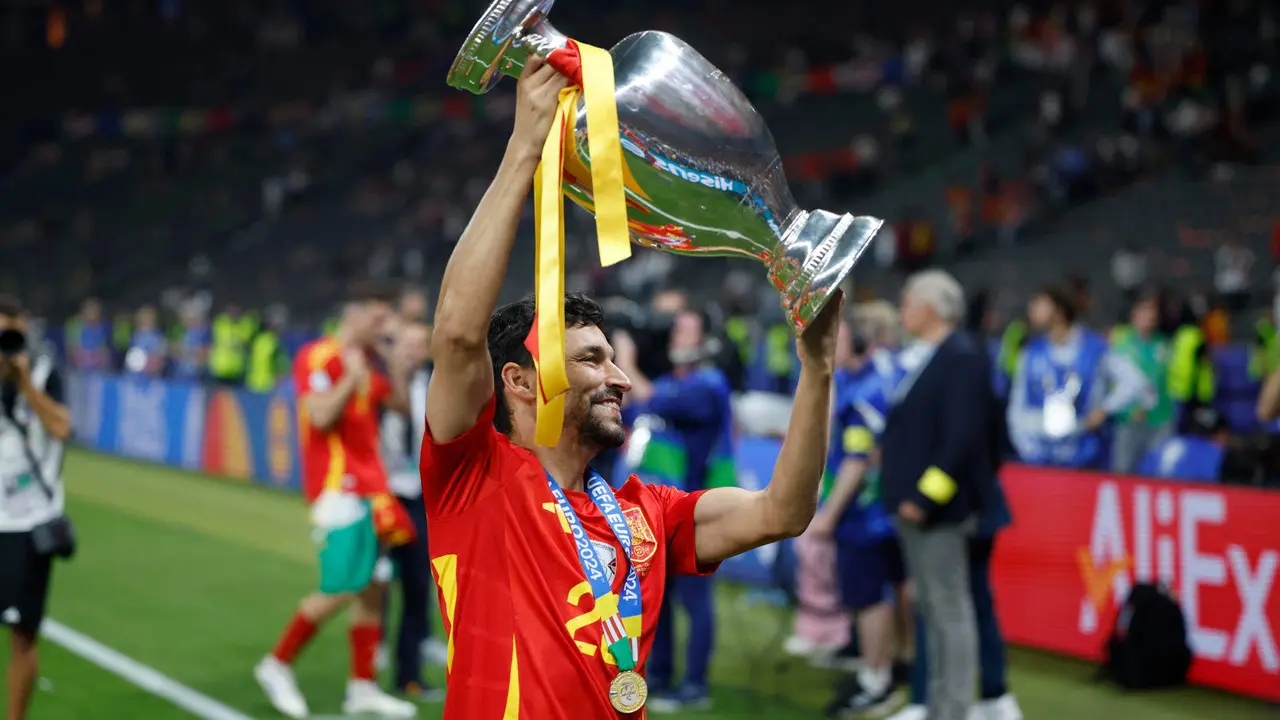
[613,311,736,712]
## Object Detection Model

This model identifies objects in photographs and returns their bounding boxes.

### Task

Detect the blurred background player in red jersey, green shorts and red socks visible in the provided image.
[253,287,416,717]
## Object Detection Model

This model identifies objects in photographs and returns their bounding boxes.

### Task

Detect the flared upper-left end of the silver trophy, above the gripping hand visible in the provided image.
[448,0,568,95]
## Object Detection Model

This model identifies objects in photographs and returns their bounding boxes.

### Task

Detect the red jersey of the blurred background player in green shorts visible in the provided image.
[293,337,390,501]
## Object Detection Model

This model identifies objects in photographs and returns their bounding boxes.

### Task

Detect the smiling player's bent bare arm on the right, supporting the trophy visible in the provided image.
[694,296,844,564]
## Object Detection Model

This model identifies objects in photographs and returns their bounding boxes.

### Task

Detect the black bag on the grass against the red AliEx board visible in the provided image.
[1102,583,1192,691]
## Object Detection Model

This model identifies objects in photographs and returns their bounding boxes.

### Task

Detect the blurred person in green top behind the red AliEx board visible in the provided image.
[1111,295,1174,473]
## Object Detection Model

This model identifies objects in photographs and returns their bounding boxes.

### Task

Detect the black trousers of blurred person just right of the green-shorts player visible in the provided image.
[384,497,431,688]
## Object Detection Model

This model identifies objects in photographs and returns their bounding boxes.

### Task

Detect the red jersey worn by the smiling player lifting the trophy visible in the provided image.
[421,400,716,720]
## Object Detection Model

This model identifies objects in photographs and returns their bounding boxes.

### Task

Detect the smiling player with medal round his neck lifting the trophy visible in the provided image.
[421,59,841,720]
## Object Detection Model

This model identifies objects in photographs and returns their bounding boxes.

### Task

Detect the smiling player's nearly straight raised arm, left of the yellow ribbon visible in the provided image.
[426,55,566,442]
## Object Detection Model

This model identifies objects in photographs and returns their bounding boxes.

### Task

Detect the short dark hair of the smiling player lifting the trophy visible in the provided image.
[489,292,604,436]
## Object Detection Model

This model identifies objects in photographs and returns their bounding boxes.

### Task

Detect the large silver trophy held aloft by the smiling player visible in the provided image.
[448,0,884,333]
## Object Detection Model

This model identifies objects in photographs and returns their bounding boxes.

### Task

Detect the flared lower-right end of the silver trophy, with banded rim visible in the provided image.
[769,210,884,334]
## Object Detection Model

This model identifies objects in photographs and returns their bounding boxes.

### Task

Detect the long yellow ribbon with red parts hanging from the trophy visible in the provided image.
[526,40,631,447]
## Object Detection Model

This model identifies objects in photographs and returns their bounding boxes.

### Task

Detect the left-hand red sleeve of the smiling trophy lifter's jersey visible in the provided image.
[420,397,500,518]
